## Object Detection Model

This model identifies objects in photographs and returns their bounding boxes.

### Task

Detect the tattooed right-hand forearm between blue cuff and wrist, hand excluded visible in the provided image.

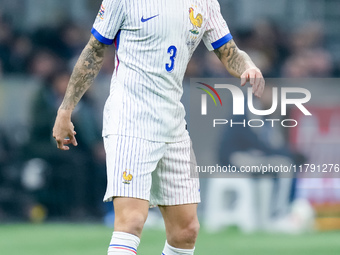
[214,40,252,76]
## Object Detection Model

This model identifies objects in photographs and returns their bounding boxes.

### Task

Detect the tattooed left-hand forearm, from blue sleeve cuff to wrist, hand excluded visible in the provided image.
[60,36,108,110]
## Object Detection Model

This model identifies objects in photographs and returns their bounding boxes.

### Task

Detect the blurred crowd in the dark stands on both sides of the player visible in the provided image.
[0,13,339,79]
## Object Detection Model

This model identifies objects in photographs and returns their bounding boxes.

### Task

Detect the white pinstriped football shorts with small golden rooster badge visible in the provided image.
[104,135,200,207]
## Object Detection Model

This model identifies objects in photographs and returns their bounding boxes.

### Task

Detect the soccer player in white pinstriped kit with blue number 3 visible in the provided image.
[53,0,264,255]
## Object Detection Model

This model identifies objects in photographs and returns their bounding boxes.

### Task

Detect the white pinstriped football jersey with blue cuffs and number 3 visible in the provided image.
[92,0,232,142]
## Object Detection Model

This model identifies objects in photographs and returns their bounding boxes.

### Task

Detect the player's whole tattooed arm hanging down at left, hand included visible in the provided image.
[53,36,108,150]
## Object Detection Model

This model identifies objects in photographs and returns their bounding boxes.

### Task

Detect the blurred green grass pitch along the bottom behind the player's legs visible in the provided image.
[0,224,340,255]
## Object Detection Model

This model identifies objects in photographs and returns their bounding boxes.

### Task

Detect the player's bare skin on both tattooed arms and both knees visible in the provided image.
[53,33,264,249]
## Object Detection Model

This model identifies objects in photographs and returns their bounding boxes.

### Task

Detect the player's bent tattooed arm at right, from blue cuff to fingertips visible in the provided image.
[214,40,265,97]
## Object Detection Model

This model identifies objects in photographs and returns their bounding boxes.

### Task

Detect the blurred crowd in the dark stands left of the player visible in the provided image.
[0,16,114,81]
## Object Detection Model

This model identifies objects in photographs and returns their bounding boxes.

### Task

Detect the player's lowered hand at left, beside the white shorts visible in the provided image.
[53,110,78,150]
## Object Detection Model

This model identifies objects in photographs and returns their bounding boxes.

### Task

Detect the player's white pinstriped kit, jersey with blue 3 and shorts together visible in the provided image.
[92,0,232,205]
